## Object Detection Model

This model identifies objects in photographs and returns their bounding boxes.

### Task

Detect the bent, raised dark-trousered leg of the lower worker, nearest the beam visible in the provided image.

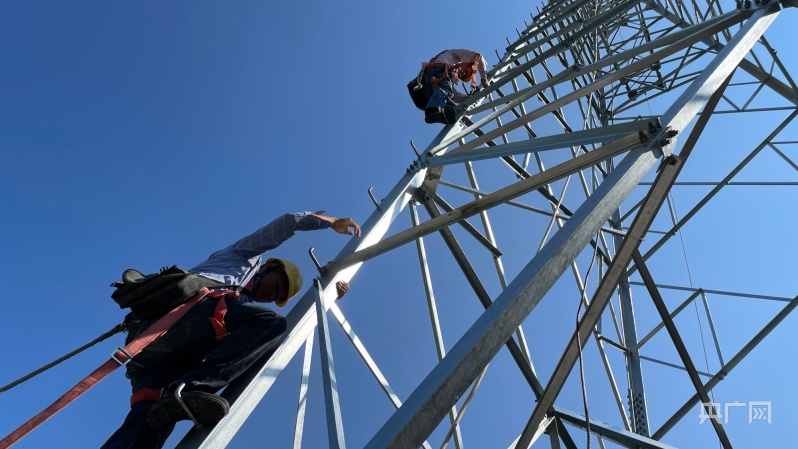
[172,301,286,393]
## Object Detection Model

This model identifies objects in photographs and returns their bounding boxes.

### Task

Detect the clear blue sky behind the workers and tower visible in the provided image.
[0,0,798,448]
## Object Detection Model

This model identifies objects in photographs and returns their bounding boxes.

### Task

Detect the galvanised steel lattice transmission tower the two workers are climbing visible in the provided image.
[179,0,798,448]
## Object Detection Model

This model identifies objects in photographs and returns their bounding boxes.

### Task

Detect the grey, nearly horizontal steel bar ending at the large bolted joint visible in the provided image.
[423,120,657,167]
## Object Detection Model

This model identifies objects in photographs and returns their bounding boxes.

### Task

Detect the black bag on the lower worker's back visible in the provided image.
[111,265,231,320]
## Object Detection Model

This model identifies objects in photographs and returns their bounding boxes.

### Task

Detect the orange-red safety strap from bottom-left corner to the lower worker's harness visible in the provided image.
[0,288,209,449]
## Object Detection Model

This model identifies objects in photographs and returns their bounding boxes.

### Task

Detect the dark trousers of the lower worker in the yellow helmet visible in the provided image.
[102,298,286,449]
